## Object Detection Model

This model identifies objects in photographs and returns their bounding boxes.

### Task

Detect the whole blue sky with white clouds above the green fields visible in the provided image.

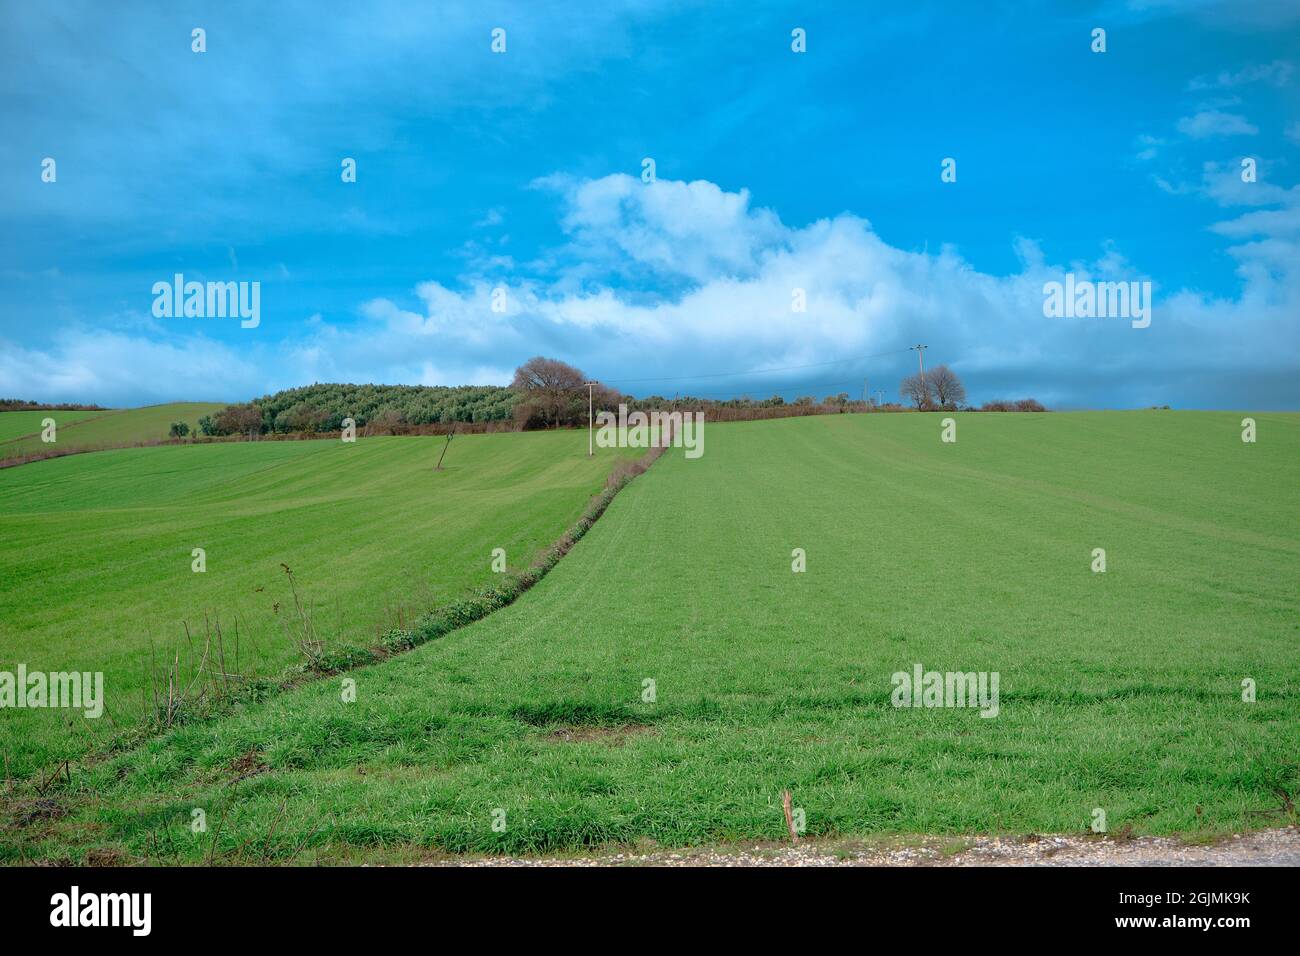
[0,0,1300,408]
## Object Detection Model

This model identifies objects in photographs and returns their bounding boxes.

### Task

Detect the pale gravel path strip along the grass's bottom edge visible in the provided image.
[426,826,1300,866]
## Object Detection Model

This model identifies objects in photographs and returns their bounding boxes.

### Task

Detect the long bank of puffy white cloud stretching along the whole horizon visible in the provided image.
[10,175,1300,405]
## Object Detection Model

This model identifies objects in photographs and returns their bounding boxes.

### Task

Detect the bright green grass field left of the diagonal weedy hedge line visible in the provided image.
[0,432,639,775]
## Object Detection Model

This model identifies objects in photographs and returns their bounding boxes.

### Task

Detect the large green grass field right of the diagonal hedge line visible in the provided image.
[0,412,1300,862]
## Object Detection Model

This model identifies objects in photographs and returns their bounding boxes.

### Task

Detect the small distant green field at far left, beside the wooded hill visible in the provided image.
[0,402,226,459]
